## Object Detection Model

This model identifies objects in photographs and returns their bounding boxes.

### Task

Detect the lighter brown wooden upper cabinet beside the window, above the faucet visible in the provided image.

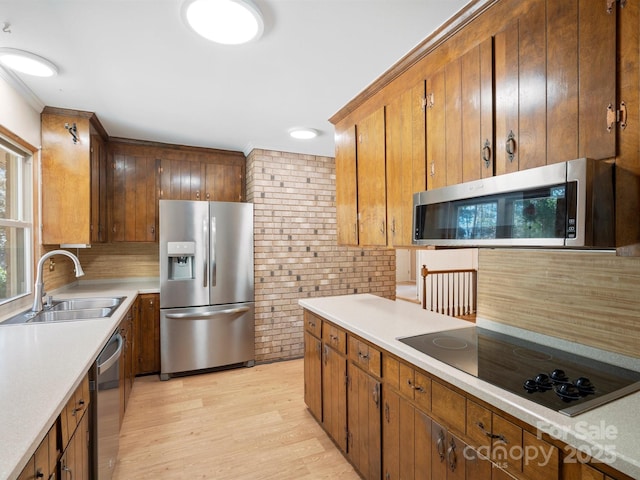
[41,107,107,245]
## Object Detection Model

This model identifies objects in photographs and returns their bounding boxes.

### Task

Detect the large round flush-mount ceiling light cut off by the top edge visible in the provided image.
[183,0,264,45]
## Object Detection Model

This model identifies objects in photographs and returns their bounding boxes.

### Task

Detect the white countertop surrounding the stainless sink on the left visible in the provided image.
[0,279,159,479]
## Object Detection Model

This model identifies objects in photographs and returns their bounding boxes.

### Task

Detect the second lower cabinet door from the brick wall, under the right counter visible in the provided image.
[322,344,347,452]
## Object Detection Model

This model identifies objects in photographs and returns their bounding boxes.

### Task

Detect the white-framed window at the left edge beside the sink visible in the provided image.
[0,136,33,303]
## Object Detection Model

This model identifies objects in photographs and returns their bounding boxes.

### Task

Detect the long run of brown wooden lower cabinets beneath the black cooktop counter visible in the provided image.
[305,311,630,480]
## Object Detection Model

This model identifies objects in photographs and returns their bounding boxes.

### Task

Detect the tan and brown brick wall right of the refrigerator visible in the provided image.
[247,149,395,362]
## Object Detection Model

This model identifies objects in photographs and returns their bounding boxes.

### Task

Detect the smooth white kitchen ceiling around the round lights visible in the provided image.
[0,0,468,156]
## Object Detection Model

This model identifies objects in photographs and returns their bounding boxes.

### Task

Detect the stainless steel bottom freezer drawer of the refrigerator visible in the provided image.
[160,302,255,380]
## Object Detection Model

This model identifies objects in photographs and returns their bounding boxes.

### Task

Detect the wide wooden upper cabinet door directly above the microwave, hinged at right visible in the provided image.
[494,0,616,175]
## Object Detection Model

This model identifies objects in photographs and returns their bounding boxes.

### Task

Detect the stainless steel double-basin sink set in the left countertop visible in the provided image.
[0,297,127,325]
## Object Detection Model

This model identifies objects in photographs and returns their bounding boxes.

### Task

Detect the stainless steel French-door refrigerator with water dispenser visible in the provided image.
[160,200,255,380]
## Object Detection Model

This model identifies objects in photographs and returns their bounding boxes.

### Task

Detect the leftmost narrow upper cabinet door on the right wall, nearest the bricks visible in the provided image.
[335,125,358,245]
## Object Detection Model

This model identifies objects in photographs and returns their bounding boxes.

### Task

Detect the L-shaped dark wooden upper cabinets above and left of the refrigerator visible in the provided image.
[109,140,245,242]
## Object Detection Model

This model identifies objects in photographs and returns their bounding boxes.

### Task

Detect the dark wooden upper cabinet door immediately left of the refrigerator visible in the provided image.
[111,151,159,242]
